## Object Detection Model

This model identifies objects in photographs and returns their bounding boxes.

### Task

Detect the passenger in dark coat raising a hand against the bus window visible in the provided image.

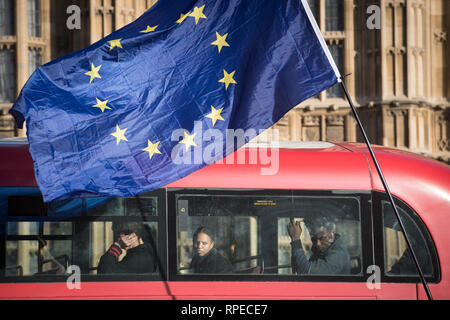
[287,216,350,275]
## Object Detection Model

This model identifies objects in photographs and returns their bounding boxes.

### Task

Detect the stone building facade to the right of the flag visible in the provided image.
[274,0,450,163]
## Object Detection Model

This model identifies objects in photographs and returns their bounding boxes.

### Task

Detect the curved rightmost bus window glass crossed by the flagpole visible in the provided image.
[381,200,437,277]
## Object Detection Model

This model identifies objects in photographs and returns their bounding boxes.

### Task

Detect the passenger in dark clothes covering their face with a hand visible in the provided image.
[97,222,156,274]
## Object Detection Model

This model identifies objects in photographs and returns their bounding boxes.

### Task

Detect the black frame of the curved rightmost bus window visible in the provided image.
[372,191,442,283]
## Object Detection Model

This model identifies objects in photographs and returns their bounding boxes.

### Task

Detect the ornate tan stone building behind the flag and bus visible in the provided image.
[0,0,450,163]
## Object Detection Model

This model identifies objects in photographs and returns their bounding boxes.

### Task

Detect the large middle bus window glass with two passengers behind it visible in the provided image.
[174,190,362,277]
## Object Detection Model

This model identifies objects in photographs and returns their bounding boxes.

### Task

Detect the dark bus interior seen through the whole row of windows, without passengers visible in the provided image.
[0,188,439,282]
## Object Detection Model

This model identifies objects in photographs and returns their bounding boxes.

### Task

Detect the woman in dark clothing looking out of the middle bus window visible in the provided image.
[189,226,233,273]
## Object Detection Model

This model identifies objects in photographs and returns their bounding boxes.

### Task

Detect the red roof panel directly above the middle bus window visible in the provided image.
[167,142,372,190]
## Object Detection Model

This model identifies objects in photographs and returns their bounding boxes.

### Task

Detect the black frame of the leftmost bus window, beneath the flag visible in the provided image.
[0,188,167,283]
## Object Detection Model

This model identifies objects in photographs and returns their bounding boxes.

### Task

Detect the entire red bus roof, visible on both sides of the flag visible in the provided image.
[0,138,450,214]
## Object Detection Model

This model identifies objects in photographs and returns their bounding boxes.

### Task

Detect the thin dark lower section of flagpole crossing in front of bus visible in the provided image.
[340,76,433,300]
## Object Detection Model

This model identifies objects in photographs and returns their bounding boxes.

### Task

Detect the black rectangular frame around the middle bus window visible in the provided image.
[167,188,373,283]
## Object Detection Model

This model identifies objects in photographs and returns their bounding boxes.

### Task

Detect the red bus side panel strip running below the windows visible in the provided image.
[0,282,417,300]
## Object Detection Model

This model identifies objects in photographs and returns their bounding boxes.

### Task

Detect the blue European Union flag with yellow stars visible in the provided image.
[10,0,339,202]
